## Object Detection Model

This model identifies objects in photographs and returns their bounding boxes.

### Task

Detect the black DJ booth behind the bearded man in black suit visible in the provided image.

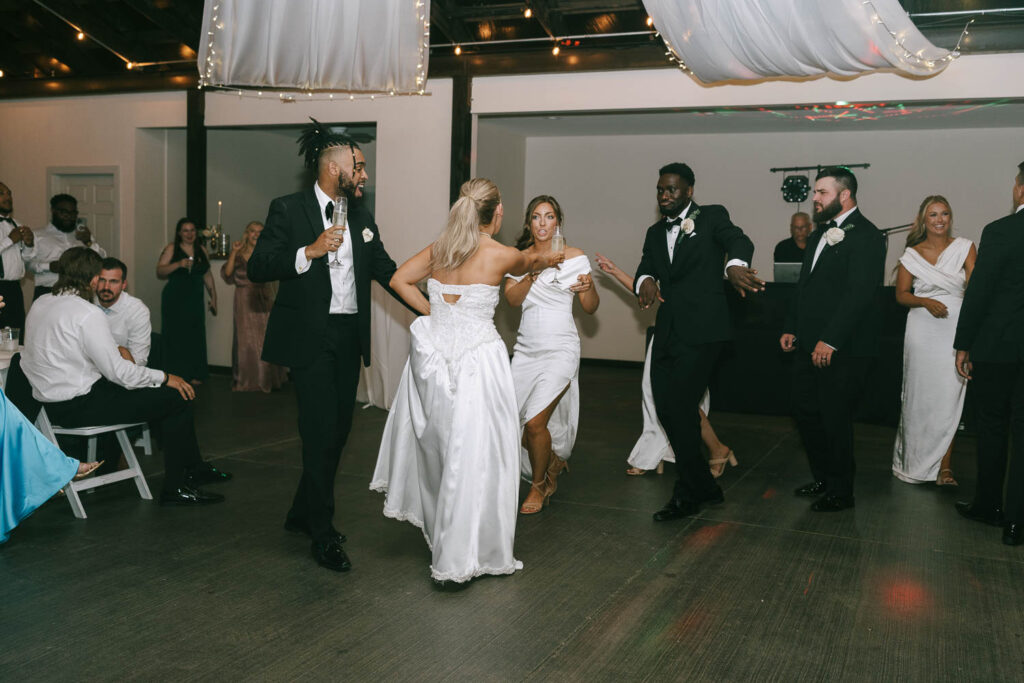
[711,282,909,425]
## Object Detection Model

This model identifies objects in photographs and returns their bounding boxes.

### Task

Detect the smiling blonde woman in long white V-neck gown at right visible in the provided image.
[893,195,978,486]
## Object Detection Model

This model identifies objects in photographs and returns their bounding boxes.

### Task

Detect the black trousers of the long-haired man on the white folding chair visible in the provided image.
[44,379,203,490]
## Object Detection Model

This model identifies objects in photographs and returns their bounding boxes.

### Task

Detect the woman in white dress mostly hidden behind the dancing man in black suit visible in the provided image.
[597,254,739,479]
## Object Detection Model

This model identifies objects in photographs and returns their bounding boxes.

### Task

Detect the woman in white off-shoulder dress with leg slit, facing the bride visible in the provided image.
[505,195,600,515]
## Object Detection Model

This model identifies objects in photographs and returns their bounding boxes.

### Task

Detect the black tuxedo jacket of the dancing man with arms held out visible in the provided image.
[633,202,754,346]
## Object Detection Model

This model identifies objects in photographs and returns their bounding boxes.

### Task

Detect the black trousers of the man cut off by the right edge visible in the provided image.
[972,361,1024,523]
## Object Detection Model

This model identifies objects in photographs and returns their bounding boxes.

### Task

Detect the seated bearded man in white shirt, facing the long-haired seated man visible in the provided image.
[96,256,153,366]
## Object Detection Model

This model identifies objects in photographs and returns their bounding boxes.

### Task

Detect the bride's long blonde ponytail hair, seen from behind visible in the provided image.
[430,178,502,271]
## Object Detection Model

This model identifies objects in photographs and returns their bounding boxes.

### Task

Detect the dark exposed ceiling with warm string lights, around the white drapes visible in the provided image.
[0,0,1024,97]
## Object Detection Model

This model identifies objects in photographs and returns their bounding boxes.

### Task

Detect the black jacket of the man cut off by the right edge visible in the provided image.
[953,211,1024,362]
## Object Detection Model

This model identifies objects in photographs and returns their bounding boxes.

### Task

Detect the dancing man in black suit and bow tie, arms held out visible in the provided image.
[633,164,764,521]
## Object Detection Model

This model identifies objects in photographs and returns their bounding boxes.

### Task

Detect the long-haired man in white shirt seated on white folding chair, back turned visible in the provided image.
[22,247,231,505]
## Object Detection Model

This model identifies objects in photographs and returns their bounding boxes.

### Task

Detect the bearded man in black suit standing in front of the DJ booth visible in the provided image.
[779,167,886,512]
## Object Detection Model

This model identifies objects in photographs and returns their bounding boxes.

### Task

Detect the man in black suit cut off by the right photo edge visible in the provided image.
[953,158,1024,546]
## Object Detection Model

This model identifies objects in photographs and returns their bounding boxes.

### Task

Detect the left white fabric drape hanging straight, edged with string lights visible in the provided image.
[199,0,430,93]
